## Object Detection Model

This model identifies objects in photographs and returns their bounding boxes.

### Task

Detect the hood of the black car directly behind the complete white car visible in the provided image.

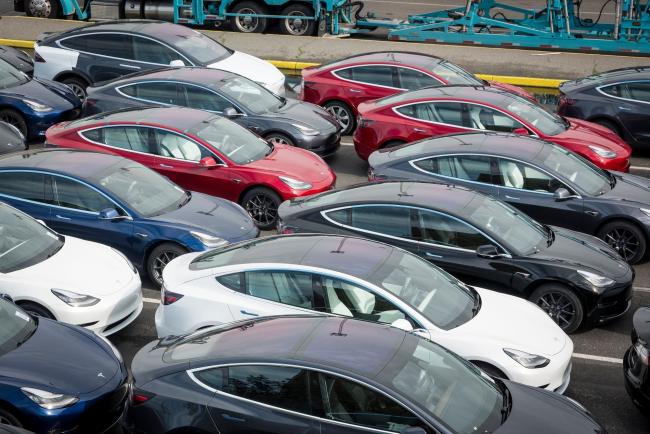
[530,226,631,279]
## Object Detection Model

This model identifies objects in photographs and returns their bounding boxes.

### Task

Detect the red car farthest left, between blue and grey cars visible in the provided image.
[46,107,336,229]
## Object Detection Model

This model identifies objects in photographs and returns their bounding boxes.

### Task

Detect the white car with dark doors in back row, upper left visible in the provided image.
[34,20,285,99]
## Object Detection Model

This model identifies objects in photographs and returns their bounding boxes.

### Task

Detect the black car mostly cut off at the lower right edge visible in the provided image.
[623,307,650,412]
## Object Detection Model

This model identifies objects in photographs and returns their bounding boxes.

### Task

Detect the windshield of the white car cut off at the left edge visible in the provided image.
[0,204,65,272]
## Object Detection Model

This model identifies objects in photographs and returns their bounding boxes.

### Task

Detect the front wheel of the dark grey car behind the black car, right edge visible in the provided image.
[598,220,648,265]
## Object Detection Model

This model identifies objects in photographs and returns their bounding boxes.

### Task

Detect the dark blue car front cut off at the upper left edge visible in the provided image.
[0,58,81,139]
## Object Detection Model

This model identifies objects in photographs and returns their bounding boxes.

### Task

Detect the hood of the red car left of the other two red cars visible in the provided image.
[245,145,333,183]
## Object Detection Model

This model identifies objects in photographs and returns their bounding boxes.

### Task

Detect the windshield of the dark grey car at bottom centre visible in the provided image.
[380,337,504,434]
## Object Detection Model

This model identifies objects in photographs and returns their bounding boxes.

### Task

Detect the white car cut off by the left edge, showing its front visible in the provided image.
[0,202,142,336]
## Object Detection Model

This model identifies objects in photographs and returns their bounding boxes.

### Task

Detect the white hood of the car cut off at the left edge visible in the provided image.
[10,237,135,297]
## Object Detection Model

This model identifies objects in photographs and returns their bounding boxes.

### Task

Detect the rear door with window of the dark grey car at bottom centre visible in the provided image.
[195,364,322,434]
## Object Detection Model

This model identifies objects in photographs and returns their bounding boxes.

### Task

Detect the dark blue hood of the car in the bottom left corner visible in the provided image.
[0,318,120,395]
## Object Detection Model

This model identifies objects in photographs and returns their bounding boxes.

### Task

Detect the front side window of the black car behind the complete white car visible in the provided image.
[415,210,491,250]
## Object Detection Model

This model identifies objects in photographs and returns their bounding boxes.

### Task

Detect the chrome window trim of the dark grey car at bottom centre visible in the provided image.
[185,362,438,434]
